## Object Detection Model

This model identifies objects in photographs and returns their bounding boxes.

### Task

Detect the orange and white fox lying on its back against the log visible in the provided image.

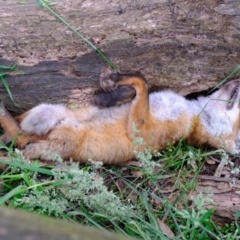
[0,74,240,164]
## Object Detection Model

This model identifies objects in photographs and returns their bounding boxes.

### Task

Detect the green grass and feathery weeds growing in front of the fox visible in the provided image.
[0,141,240,240]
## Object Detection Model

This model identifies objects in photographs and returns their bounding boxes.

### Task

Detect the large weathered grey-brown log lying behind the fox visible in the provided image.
[0,0,240,112]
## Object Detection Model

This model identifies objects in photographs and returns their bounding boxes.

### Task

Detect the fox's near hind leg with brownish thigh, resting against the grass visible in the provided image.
[0,104,77,160]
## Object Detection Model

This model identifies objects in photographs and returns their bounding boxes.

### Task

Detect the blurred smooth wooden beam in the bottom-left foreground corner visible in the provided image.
[0,207,137,240]
